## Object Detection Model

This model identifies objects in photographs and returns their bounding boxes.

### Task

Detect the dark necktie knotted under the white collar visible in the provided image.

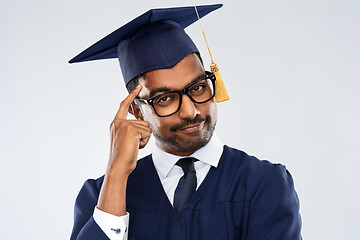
[174,158,197,212]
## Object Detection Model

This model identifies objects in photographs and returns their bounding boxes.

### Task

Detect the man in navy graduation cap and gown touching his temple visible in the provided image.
[70,5,301,240]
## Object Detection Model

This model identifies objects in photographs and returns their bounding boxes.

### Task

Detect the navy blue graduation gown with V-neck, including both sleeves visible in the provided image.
[71,146,302,240]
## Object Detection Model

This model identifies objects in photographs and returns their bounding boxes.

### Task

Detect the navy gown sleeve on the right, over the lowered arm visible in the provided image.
[246,164,302,240]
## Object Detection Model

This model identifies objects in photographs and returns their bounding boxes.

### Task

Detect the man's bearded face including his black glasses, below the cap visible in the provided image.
[134,54,216,156]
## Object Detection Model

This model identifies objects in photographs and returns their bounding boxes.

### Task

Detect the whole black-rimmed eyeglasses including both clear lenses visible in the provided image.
[134,72,216,117]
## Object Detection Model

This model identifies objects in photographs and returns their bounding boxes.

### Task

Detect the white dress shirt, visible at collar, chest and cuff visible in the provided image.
[93,132,224,240]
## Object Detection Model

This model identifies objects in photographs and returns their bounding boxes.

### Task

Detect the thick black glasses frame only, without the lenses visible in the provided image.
[134,71,216,117]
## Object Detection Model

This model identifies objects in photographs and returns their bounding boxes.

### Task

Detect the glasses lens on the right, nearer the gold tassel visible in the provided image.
[188,78,214,103]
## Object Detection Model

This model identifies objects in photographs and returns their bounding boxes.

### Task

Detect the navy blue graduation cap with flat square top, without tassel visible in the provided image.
[69,4,229,102]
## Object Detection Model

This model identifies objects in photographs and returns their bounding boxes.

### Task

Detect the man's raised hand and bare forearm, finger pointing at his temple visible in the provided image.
[97,85,151,216]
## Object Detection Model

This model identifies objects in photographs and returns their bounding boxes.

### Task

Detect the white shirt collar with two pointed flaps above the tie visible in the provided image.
[152,132,224,178]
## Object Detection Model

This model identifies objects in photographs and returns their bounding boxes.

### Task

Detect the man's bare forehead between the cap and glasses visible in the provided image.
[139,54,205,97]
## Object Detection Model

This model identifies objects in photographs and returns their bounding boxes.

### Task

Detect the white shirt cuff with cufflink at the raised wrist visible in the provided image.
[93,207,130,240]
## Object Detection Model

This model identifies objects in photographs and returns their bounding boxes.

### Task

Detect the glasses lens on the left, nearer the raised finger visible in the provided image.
[153,92,180,116]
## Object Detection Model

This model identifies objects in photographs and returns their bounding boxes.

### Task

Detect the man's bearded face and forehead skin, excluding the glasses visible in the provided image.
[139,54,217,156]
